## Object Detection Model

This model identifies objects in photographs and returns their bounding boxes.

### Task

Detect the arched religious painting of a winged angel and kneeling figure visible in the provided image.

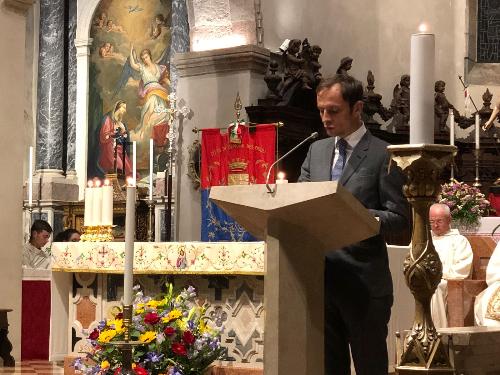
[87,0,172,180]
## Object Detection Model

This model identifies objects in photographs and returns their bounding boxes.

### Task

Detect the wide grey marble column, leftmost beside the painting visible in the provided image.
[36,0,64,175]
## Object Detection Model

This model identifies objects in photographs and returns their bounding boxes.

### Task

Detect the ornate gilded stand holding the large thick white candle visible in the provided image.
[388,144,457,375]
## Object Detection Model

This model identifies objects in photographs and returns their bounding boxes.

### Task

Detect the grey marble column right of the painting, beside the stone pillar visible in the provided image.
[170,0,189,91]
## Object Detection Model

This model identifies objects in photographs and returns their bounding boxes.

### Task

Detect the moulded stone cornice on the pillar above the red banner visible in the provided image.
[174,45,270,77]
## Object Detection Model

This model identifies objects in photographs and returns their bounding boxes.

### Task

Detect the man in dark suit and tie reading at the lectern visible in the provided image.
[299,74,409,375]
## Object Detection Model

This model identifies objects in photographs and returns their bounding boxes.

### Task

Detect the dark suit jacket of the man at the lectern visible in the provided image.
[299,130,409,300]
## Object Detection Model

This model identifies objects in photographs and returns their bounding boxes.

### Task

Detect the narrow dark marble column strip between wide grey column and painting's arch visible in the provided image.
[66,0,76,178]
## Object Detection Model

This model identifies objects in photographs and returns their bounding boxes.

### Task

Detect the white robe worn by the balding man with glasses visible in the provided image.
[431,229,473,328]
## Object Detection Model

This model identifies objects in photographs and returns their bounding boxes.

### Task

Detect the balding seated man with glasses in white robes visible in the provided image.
[429,203,472,328]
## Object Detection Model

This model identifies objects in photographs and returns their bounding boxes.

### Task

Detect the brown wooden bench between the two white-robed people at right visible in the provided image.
[447,235,496,327]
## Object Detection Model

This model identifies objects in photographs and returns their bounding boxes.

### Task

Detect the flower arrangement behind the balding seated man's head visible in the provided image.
[438,181,490,231]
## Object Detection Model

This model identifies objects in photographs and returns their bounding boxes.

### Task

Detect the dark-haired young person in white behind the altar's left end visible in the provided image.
[23,220,52,269]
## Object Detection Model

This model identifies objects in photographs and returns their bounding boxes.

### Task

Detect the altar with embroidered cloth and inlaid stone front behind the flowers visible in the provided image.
[49,242,265,368]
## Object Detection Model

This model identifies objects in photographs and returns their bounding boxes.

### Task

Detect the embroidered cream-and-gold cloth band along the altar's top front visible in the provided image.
[52,242,265,275]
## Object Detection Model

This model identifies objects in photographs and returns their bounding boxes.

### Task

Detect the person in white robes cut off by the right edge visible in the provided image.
[474,242,500,327]
